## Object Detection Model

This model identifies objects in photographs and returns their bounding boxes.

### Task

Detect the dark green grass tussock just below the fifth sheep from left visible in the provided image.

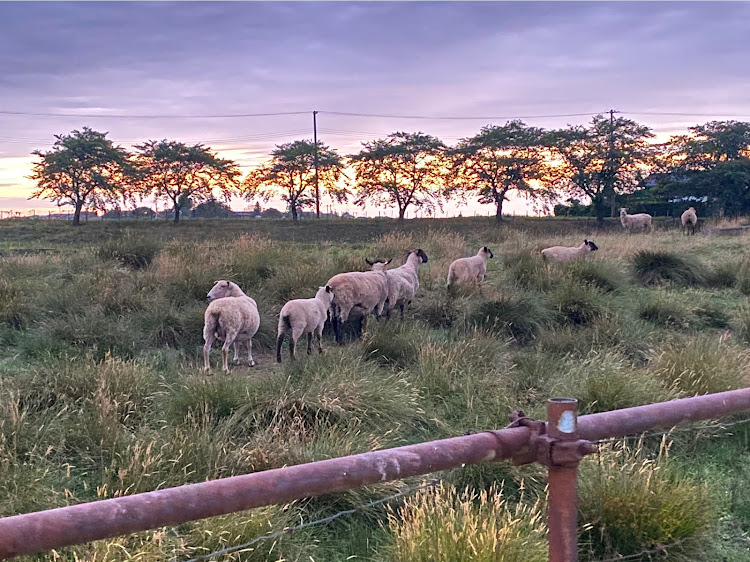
[467,295,556,345]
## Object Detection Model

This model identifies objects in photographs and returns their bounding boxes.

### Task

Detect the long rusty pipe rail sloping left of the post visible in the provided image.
[0,427,530,559]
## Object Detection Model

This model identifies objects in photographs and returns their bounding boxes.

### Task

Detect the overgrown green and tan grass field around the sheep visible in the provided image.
[0,218,750,562]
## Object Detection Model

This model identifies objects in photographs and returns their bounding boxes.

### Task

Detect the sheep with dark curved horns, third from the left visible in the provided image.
[326,259,391,344]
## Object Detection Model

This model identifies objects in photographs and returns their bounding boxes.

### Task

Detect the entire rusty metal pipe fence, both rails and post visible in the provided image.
[0,388,750,562]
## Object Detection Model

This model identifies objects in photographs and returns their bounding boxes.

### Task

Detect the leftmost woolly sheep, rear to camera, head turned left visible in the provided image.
[203,280,260,372]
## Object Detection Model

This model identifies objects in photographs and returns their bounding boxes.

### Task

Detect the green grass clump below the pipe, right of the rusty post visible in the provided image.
[578,440,715,560]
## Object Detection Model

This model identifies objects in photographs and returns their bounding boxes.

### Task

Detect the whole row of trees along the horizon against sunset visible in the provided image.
[29,113,750,225]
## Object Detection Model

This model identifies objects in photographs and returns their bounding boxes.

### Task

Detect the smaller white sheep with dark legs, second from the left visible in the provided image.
[276,285,333,363]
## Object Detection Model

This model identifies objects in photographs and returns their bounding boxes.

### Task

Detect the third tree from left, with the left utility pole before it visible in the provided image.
[242,140,349,222]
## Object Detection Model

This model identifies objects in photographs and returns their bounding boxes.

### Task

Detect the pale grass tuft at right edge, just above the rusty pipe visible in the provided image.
[649,336,750,396]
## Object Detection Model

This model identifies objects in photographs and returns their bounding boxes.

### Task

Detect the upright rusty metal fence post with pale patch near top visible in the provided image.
[546,398,578,562]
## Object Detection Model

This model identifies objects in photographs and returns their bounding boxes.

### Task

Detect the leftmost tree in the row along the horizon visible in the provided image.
[29,127,130,225]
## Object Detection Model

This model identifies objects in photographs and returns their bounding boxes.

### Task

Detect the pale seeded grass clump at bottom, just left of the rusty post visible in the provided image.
[388,485,547,562]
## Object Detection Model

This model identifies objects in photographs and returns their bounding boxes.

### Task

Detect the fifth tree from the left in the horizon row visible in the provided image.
[451,121,544,222]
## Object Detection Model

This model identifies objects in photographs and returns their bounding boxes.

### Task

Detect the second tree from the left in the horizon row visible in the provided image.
[135,140,240,224]
